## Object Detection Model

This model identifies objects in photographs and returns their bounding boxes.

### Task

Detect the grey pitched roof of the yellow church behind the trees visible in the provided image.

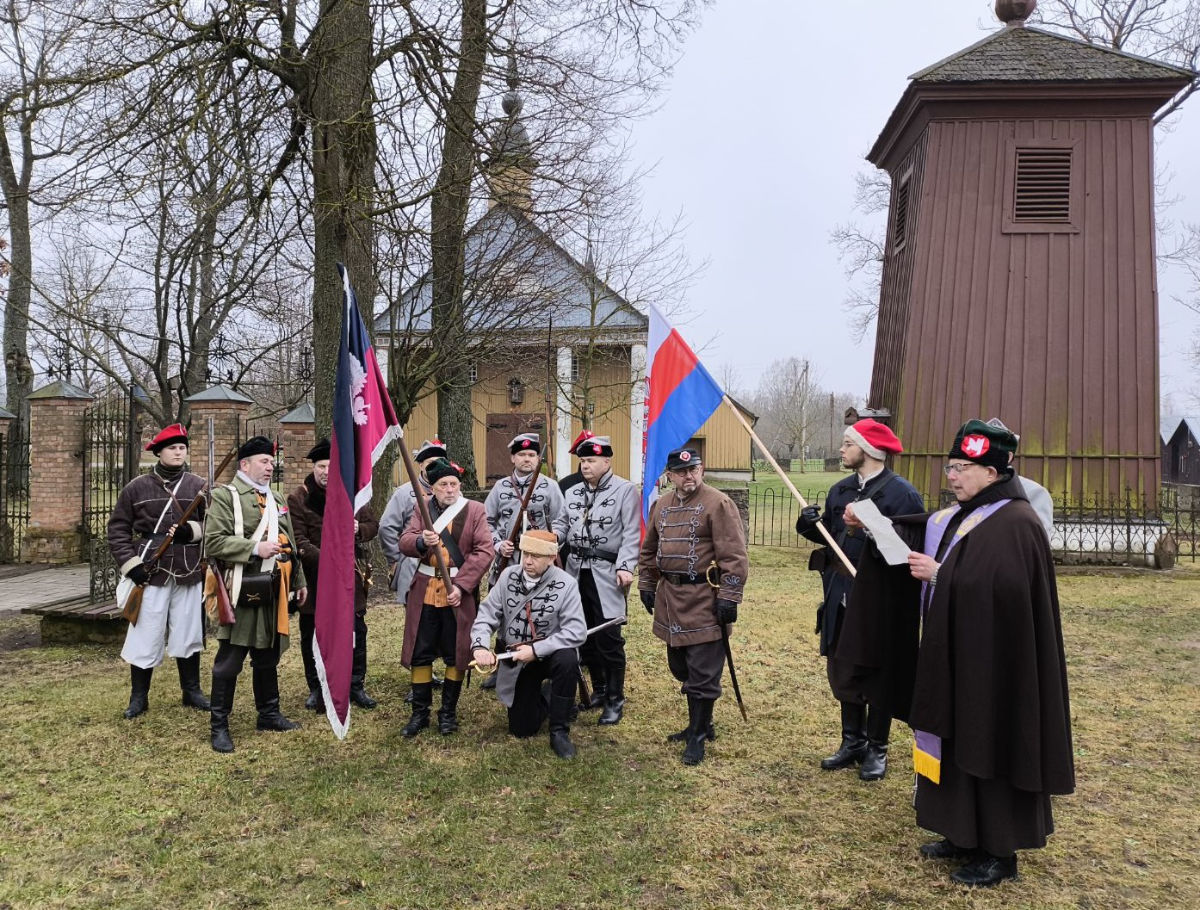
[374,205,649,334]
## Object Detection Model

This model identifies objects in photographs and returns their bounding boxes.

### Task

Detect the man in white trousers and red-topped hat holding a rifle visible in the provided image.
[108,424,209,718]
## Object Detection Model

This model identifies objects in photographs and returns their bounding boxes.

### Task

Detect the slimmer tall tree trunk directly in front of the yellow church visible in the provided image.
[431,0,487,489]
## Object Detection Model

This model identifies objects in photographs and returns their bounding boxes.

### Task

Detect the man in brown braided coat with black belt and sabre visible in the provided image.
[637,449,750,765]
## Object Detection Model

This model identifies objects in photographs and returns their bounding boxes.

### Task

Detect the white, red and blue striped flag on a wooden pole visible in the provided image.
[642,305,725,527]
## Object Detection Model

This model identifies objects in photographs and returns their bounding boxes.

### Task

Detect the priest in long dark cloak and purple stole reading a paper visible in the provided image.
[838,420,1075,886]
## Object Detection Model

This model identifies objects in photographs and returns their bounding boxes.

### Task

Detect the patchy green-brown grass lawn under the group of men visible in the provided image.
[0,549,1200,910]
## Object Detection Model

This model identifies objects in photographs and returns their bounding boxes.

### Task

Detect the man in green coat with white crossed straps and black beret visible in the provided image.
[204,436,308,752]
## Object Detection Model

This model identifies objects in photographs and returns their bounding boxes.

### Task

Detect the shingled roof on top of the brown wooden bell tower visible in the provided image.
[908,26,1195,83]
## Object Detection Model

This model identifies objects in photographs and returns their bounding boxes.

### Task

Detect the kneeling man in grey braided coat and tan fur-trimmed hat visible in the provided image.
[470,531,587,759]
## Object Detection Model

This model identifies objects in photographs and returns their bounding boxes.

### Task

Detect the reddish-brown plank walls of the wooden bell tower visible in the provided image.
[869,116,1160,502]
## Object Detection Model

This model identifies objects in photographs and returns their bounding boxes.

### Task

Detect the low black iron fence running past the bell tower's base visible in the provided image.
[749,486,1200,568]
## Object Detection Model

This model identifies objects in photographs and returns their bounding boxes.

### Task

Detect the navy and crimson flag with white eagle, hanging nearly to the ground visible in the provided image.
[313,263,404,740]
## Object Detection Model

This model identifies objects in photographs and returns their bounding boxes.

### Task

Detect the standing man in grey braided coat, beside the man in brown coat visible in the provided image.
[554,436,641,724]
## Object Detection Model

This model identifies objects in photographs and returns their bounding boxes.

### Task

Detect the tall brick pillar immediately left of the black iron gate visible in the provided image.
[20,381,92,565]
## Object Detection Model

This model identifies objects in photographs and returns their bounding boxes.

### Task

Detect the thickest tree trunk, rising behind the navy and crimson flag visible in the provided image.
[306,0,378,437]
